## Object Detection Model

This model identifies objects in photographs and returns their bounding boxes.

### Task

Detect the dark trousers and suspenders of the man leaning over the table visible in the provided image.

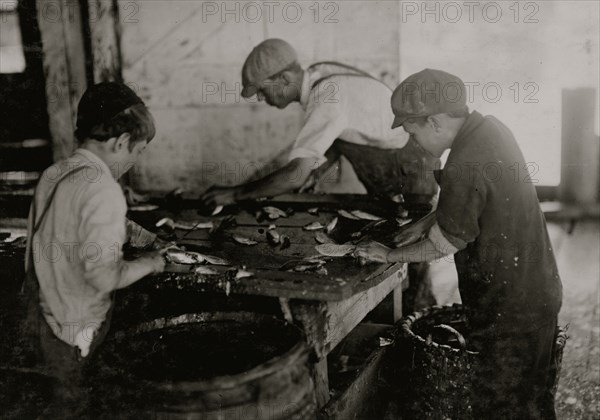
[309,62,441,313]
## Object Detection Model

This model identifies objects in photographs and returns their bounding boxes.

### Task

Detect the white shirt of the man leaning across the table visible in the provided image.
[289,64,409,165]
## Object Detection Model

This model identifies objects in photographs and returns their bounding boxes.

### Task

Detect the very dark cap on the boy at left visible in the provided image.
[77,82,144,138]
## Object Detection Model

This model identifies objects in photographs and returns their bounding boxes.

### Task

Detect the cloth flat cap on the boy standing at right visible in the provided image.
[392,69,467,128]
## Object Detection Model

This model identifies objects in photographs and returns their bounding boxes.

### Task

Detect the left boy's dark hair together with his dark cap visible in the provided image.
[75,82,156,151]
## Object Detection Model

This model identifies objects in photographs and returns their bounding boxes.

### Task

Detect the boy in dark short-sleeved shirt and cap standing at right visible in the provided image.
[356,69,562,419]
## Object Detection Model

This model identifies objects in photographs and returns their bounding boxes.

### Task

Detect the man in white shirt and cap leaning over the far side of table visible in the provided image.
[202,39,439,309]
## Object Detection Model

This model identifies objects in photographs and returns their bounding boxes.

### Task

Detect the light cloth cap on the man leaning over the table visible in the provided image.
[242,38,298,98]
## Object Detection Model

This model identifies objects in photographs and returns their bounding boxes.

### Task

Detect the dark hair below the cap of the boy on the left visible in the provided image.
[75,104,156,151]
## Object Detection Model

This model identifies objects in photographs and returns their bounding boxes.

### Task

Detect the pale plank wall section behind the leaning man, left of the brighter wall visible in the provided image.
[119,0,398,192]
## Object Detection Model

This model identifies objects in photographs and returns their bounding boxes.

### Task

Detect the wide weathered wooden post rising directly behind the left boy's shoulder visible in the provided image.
[36,0,87,161]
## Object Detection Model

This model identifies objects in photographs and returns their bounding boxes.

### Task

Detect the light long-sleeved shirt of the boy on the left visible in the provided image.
[29,149,127,356]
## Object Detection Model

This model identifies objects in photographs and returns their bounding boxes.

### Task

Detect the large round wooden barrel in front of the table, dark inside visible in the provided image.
[93,312,316,420]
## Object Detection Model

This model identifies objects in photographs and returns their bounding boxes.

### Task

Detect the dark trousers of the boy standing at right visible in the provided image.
[472,319,557,420]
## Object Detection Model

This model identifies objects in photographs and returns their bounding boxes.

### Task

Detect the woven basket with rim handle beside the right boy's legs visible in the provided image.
[394,304,567,419]
